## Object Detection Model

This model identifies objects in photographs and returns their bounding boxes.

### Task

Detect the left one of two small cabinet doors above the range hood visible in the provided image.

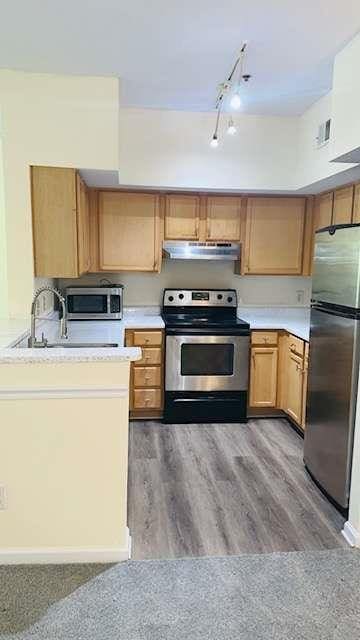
[165,194,200,240]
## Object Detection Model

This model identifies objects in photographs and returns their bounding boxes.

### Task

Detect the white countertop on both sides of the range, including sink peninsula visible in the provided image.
[0,307,310,363]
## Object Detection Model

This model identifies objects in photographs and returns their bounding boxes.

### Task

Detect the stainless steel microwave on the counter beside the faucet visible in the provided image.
[65,285,124,320]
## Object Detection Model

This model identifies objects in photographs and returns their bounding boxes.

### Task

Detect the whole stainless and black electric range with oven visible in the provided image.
[162,289,250,423]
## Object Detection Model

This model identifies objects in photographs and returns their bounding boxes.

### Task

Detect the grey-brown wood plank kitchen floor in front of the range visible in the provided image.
[128,419,346,559]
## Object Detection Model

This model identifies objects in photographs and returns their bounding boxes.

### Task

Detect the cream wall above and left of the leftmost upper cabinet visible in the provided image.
[0,70,119,317]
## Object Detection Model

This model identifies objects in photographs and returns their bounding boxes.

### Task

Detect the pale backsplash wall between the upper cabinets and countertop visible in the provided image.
[58,260,311,307]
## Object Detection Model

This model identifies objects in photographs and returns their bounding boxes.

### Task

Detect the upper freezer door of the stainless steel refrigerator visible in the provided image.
[312,225,360,308]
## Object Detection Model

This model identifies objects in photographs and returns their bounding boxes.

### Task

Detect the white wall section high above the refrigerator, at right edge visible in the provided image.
[331,34,360,162]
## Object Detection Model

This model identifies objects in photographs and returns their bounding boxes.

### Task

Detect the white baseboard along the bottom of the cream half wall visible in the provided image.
[0,527,131,566]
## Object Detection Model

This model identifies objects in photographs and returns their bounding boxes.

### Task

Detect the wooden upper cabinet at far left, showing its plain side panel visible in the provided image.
[31,167,89,278]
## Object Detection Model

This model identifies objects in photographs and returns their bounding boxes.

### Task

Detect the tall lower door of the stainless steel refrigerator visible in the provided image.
[304,308,359,509]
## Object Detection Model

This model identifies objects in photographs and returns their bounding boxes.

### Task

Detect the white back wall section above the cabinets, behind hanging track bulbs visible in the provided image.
[119,109,298,191]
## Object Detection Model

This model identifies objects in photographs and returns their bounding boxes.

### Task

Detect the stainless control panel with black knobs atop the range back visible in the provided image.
[163,289,237,307]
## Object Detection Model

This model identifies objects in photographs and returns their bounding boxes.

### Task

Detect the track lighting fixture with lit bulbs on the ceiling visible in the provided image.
[210,42,251,147]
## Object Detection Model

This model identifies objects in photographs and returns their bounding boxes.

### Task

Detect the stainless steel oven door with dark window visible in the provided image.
[165,335,249,391]
